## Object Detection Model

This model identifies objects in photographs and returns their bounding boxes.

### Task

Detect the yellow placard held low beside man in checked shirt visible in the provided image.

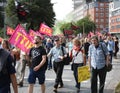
[78,66,90,82]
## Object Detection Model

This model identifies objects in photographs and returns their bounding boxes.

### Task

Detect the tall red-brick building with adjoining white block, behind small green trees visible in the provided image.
[73,0,109,31]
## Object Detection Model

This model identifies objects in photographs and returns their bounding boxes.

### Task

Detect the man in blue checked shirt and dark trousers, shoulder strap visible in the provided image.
[88,36,110,93]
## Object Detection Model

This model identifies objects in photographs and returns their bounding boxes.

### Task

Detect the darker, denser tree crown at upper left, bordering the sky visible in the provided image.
[17,0,55,30]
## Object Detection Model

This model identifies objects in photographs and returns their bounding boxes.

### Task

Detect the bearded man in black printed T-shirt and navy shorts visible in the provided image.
[28,36,47,93]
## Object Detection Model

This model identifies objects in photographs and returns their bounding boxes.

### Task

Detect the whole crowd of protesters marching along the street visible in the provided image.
[0,31,119,93]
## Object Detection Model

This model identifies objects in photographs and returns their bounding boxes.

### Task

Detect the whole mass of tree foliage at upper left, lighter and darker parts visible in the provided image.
[5,0,55,30]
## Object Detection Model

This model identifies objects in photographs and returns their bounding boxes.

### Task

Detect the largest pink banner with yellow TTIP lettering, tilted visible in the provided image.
[9,25,34,52]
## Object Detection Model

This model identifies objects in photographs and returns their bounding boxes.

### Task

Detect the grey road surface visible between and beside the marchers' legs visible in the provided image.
[11,57,120,93]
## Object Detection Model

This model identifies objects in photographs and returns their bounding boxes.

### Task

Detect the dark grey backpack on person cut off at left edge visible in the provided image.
[0,49,10,74]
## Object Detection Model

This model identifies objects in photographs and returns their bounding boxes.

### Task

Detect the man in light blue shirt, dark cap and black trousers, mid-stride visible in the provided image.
[48,38,67,92]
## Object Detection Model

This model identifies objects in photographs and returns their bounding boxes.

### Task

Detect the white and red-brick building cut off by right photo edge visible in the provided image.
[109,0,120,34]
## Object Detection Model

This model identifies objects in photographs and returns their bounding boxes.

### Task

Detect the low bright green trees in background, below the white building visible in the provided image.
[60,16,96,35]
